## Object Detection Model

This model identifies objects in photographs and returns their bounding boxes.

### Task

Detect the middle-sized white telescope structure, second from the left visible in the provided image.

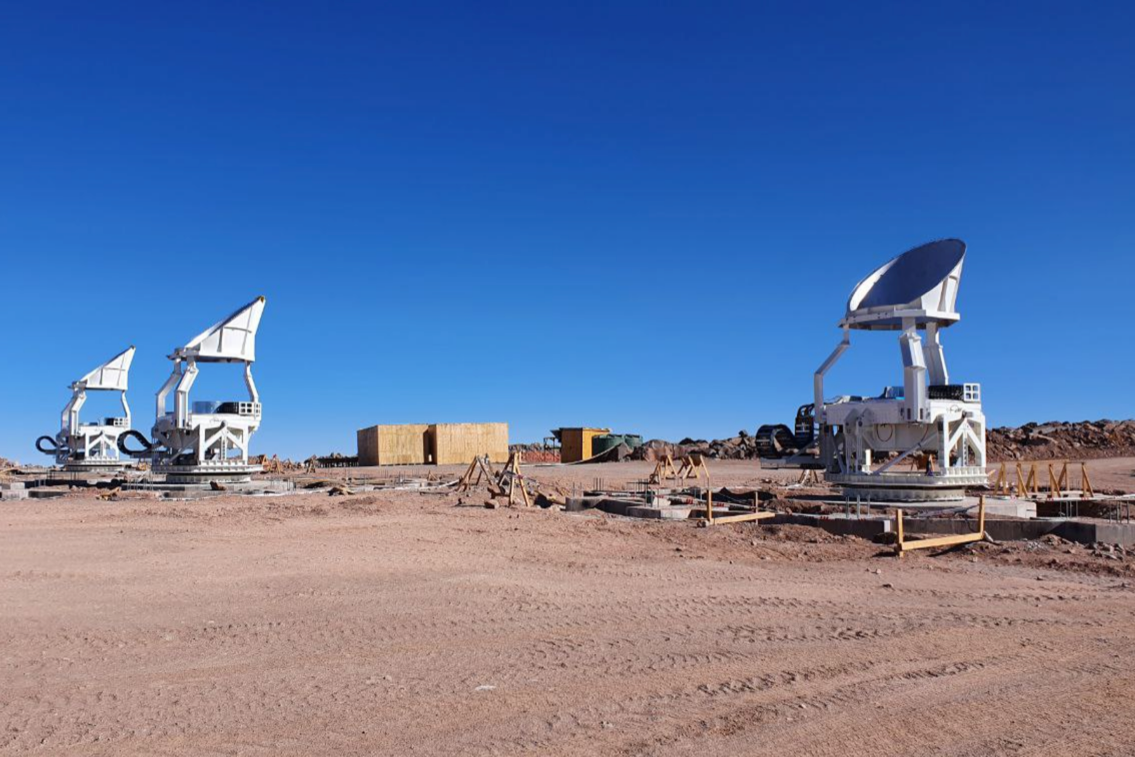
[118,297,264,483]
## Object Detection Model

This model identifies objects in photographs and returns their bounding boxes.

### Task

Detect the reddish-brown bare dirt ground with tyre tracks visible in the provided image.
[0,461,1135,757]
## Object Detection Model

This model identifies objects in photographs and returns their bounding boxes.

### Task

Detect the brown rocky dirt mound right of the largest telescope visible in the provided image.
[986,420,1135,462]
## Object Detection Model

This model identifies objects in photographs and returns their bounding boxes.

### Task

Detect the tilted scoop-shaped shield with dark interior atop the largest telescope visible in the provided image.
[840,239,966,330]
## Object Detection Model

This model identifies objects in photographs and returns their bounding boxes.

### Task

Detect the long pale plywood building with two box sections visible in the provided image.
[358,423,508,465]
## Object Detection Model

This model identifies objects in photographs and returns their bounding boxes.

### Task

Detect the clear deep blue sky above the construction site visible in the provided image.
[0,0,1135,462]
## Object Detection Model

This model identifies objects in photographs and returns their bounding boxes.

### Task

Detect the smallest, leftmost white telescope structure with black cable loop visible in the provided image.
[35,347,134,471]
